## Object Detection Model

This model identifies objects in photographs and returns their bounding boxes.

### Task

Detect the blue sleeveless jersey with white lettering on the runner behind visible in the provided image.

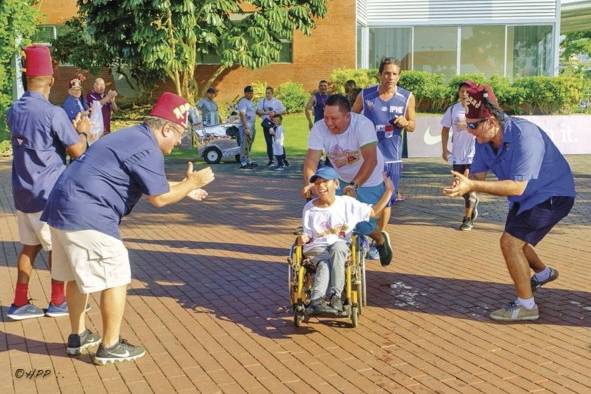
[361,85,411,163]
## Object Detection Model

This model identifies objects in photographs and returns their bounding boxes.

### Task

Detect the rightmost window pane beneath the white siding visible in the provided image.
[507,26,554,78]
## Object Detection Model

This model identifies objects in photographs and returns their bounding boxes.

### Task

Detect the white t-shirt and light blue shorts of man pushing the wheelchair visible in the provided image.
[308,112,384,187]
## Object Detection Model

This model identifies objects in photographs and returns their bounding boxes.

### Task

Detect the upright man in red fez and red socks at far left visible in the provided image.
[7,46,90,320]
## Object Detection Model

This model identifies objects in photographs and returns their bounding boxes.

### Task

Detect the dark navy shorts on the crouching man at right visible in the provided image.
[505,197,575,246]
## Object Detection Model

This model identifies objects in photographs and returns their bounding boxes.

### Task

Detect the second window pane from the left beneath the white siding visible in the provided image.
[413,26,458,77]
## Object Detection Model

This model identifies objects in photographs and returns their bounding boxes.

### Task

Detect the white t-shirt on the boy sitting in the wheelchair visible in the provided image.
[302,196,372,253]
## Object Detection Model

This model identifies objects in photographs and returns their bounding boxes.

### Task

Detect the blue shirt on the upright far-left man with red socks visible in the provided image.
[8,92,80,213]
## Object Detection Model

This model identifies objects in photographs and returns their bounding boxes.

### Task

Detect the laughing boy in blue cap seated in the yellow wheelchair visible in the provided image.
[296,167,393,315]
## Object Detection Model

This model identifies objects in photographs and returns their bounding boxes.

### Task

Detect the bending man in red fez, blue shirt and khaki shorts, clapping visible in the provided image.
[42,93,214,364]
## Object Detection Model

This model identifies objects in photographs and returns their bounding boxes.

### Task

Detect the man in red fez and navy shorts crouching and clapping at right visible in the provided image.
[443,82,576,321]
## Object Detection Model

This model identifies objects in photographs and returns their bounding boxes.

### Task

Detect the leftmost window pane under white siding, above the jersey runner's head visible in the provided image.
[369,27,412,70]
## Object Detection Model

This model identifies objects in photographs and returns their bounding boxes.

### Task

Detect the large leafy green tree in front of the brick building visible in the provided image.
[56,0,328,101]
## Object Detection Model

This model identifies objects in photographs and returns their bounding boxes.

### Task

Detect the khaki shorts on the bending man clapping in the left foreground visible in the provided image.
[50,227,131,294]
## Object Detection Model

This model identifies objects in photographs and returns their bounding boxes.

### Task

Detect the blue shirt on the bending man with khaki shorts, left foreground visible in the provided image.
[41,125,169,238]
